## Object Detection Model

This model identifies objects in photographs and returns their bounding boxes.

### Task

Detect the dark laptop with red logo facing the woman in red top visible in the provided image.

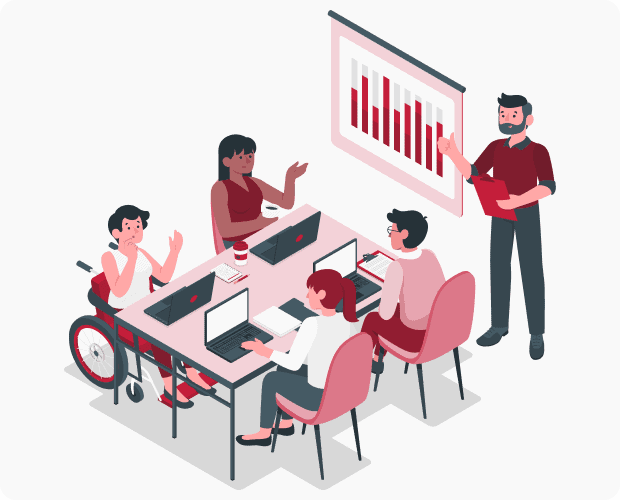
[250,212,321,265]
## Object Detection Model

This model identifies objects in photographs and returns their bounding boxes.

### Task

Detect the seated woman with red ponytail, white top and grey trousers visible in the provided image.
[237,269,357,446]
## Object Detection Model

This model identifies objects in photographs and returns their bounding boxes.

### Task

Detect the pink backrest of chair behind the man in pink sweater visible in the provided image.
[416,271,476,363]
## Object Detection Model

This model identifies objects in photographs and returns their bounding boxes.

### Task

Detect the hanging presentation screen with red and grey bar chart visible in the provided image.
[329,11,465,217]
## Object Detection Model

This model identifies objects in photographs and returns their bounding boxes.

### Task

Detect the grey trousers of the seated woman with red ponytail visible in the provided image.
[260,365,323,429]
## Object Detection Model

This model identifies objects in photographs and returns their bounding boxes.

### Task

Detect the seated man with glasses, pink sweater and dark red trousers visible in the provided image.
[362,209,446,373]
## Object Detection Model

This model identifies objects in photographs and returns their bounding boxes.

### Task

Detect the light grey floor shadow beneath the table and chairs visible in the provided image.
[65,348,480,490]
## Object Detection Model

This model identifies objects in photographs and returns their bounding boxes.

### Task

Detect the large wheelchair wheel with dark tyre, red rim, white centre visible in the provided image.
[69,316,128,389]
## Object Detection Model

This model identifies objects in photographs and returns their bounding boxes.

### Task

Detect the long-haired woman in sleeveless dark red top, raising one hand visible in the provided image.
[211,135,308,248]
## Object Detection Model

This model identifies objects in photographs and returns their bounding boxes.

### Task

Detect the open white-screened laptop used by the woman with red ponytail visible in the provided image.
[205,288,273,363]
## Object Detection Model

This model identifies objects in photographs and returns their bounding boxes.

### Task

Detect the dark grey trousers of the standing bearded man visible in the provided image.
[491,204,545,335]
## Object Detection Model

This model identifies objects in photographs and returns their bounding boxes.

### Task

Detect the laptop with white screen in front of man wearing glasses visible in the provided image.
[313,238,381,312]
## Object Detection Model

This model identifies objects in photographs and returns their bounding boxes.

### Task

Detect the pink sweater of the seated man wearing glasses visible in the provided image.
[379,249,446,330]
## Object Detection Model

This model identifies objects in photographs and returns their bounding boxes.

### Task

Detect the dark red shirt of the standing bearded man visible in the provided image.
[467,137,555,208]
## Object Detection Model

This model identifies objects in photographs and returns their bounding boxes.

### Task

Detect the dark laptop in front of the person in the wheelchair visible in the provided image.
[144,272,215,326]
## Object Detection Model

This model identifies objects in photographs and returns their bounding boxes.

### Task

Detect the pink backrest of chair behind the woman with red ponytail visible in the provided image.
[313,332,373,425]
